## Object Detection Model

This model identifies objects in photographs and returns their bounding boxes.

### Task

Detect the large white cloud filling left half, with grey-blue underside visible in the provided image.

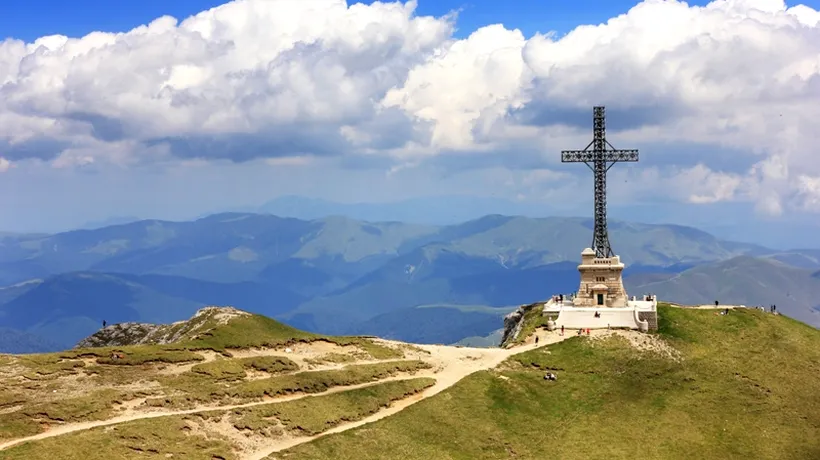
[0,0,453,161]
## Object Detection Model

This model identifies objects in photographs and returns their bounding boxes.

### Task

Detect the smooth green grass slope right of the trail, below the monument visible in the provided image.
[277,306,820,460]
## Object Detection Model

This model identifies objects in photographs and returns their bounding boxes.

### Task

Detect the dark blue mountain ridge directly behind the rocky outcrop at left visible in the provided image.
[0,272,306,351]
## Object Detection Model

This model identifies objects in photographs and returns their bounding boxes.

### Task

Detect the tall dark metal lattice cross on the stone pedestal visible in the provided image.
[561,107,638,257]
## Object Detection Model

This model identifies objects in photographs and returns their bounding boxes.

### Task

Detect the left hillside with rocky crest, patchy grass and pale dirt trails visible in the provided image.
[0,307,544,460]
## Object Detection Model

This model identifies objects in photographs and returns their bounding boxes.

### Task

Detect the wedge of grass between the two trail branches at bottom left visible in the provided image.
[1,378,434,460]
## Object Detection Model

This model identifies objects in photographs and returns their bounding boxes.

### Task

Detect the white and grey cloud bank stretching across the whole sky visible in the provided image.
[0,0,820,214]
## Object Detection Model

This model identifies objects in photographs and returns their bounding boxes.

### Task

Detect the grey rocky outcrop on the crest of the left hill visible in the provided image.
[75,307,250,348]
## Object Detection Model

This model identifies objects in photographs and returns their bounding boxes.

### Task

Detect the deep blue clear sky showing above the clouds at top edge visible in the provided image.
[0,0,736,41]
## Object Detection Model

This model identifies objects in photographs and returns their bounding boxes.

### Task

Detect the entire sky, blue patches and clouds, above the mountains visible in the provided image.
[0,0,820,243]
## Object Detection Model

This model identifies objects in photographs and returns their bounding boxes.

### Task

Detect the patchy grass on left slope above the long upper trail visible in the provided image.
[0,312,414,446]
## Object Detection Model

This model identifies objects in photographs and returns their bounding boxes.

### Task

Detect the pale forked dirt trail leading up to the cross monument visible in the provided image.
[0,330,571,460]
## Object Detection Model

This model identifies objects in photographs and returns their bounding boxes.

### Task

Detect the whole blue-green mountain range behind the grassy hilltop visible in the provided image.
[0,213,820,351]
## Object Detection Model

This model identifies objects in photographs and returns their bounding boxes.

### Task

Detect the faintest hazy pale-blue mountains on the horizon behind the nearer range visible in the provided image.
[256,192,820,250]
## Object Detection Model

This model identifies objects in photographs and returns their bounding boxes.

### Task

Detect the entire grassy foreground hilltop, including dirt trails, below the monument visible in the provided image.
[0,305,820,460]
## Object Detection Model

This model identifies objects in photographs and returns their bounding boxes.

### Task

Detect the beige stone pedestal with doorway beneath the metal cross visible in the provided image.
[574,248,627,307]
